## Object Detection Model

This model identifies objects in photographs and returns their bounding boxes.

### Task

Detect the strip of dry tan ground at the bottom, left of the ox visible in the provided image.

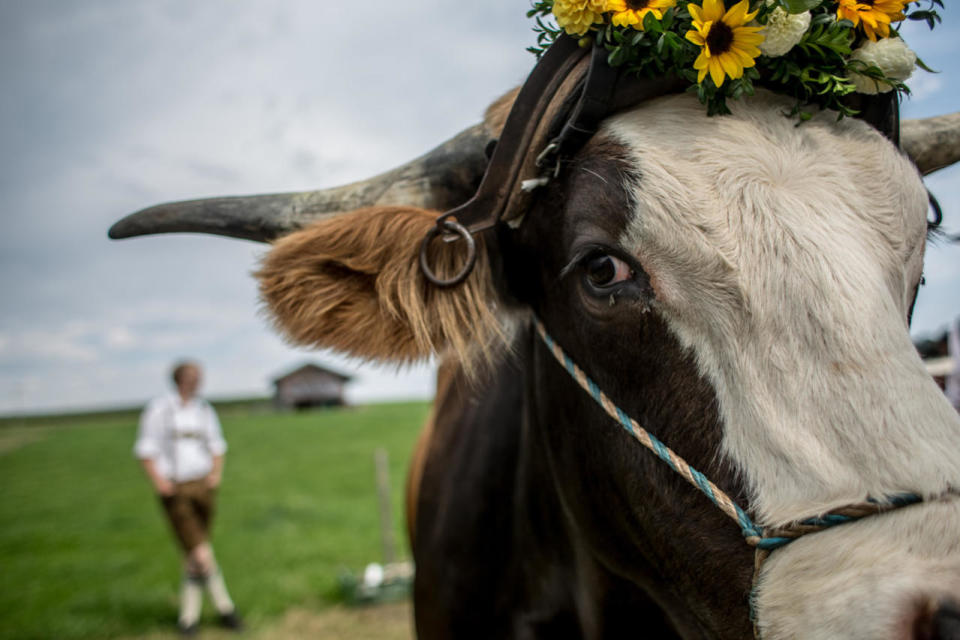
[127,602,413,640]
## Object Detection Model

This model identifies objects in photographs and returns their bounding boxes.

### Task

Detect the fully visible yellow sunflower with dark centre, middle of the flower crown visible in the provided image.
[687,0,763,87]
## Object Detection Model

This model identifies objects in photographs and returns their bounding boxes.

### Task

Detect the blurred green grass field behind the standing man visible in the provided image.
[0,403,428,639]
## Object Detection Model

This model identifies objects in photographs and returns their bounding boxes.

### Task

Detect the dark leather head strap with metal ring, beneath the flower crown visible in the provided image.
[420,35,900,287]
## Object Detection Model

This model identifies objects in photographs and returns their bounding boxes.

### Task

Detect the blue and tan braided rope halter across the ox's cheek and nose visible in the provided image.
[534,319,958,556]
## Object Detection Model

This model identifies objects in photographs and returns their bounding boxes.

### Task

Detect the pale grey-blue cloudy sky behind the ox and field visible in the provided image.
[0,0,960,413]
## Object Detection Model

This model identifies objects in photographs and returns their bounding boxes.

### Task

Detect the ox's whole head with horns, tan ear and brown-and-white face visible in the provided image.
[111,50,960,640]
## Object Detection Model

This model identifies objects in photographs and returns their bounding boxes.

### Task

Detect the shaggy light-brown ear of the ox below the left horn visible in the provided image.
[256,207,503,363]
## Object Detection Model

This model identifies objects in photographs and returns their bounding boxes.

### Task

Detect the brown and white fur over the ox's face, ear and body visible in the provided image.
[249,89,960,640]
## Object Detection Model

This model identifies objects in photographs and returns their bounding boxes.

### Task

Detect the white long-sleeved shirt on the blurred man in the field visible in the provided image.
[133,393,227,482]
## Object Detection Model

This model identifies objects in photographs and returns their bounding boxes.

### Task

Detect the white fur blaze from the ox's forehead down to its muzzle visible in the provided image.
[606,95,960,640]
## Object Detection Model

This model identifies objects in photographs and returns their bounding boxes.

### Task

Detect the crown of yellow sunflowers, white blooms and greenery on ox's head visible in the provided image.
[527,0,943,120]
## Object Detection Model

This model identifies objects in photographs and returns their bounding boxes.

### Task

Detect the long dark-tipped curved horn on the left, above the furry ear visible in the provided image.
[109,124,491,242]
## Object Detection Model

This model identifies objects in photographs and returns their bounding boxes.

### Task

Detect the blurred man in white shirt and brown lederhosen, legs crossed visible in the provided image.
[133,361,241,635]
